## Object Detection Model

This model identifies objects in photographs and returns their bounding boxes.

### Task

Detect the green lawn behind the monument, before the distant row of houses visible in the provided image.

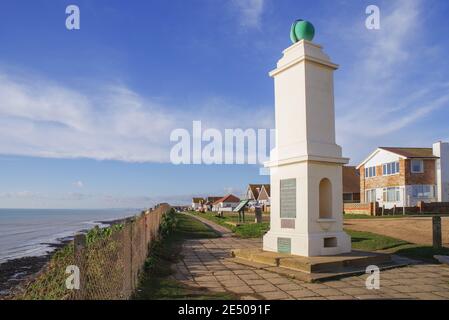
[191,212,270,238]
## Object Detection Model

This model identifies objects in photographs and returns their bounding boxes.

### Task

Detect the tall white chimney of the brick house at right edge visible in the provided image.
[433,141,449,202]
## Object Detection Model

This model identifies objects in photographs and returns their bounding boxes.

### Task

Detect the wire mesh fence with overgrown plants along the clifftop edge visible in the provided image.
[13,204,170,300]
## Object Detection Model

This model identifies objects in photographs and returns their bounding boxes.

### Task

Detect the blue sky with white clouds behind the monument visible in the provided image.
[0,0,449,208]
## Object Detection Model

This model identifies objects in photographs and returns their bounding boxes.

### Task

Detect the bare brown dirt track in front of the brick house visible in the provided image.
[344,217,449,246]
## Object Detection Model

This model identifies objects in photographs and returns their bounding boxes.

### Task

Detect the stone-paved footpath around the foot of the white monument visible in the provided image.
[173,215,449,300]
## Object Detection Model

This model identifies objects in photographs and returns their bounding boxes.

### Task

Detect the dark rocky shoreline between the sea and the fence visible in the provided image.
[0,216,134,300]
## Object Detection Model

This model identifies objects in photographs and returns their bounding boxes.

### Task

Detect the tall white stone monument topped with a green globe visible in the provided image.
[263,21,351,257]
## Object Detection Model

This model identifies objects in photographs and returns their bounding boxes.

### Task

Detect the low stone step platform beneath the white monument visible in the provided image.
[232,249,410,282]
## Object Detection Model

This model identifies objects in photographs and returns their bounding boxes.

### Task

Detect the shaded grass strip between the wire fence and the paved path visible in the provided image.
[133,214,236,300]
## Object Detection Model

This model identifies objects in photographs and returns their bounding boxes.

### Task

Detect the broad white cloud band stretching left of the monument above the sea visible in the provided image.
[0,70,272,162]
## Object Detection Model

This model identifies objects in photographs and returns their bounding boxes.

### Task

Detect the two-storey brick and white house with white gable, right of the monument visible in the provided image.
[357,142,449,209]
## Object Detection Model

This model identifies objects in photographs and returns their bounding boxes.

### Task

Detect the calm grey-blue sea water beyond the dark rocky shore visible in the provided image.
[0,209,139,263]
